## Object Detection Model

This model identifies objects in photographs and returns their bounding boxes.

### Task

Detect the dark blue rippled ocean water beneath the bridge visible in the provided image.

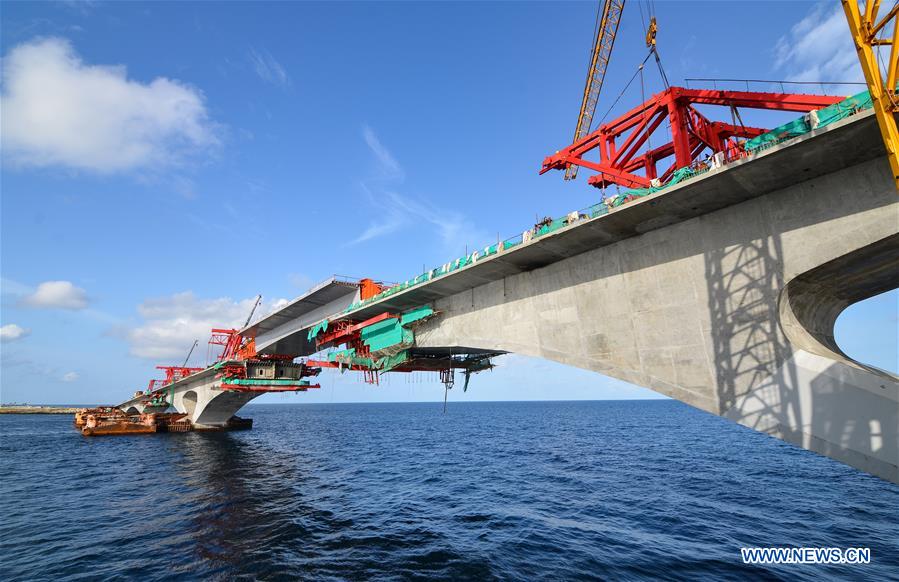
[0,401,899,581]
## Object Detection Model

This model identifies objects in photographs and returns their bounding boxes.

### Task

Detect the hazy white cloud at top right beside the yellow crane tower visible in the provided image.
[774,2,864,84]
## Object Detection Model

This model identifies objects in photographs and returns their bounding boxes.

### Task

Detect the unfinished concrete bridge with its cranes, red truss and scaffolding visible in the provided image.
[77,1,899,483]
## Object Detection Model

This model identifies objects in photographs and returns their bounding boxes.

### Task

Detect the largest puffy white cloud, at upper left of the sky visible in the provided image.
[0,38,218,173]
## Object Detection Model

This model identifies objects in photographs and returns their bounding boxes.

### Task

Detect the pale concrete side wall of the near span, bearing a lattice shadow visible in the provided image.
[416,157,899,483]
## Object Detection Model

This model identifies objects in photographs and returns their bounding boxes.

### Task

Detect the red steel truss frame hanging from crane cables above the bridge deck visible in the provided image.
[540,87,843,188]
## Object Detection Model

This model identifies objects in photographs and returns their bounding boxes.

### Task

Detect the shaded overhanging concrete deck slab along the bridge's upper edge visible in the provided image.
[248,111,899,356]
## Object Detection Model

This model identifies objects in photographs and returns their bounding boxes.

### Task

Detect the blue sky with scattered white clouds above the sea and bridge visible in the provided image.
[0,2,897,403]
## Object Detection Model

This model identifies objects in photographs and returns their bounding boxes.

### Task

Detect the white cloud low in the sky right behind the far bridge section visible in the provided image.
[122,291,288,363]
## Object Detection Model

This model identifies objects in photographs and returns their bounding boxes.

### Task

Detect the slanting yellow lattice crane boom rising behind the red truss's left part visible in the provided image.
[565,0,625,180]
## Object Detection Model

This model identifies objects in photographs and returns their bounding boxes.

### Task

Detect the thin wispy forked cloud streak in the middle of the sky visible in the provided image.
[347,125,487,253]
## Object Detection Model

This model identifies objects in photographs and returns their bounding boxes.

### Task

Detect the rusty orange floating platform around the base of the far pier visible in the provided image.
[75,407,253,436]
